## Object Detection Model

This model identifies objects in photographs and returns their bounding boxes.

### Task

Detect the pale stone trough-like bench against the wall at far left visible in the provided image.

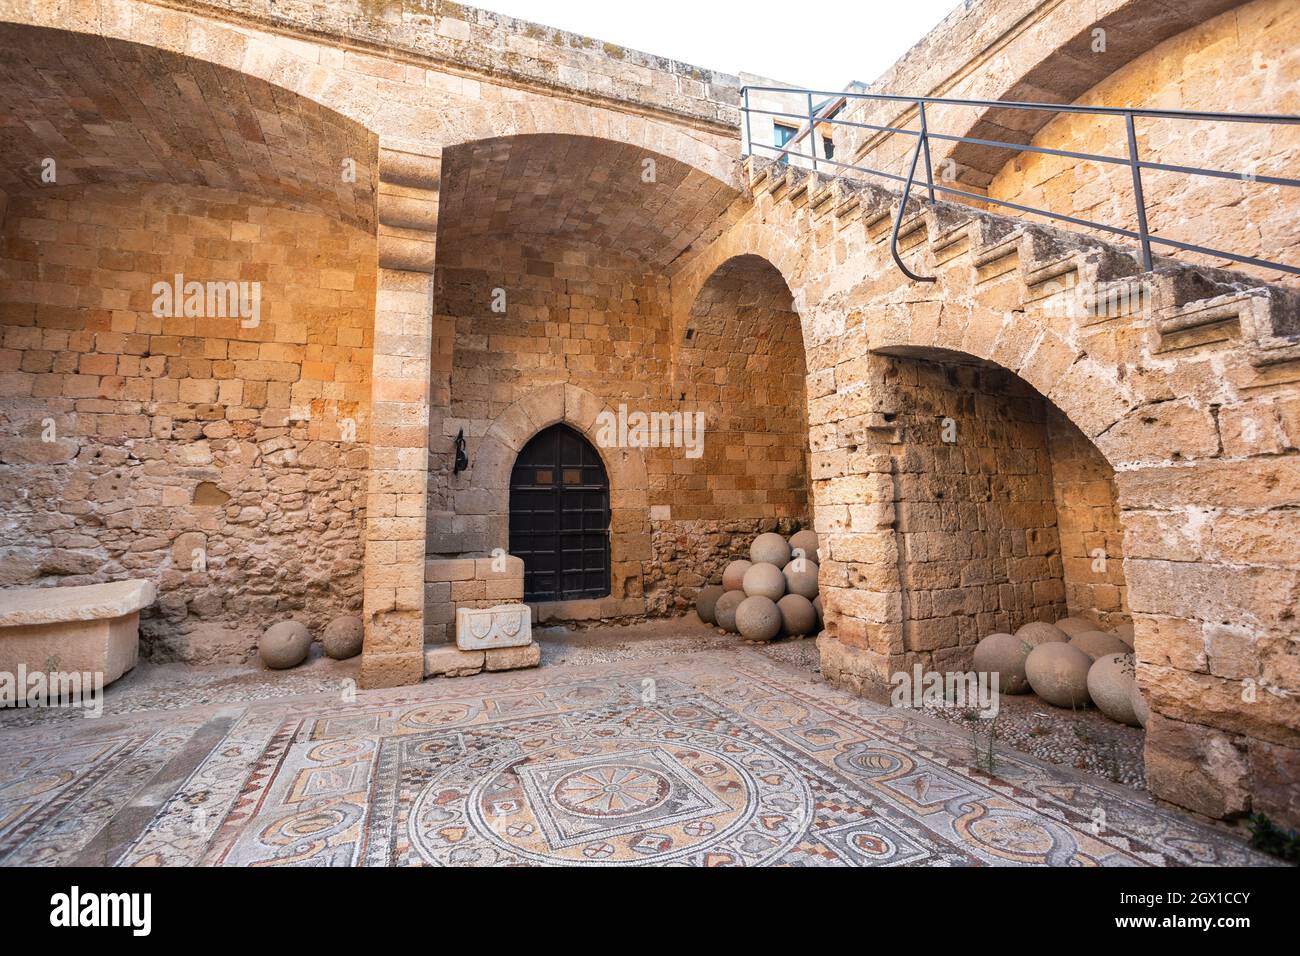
[0,580,157,684]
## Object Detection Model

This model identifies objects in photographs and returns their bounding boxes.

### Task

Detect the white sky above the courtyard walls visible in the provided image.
[468,0,959,92]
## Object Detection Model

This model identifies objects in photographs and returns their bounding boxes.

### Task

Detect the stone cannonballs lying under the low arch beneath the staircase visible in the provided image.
[975,618,1148,727]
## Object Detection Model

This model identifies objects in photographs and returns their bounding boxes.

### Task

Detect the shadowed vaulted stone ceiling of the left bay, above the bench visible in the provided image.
[0,23,376,226]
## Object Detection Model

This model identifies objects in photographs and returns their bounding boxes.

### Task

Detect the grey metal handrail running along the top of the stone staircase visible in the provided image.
[741,86,1300,282]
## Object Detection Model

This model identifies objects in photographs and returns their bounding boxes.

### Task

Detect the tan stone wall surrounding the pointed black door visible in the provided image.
[428,241,809,637]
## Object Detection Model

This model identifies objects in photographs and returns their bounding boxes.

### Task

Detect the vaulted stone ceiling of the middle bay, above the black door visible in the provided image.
[438,134,740,268]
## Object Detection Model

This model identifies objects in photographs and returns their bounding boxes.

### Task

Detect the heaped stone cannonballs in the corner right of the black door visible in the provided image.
[696,531,822,641]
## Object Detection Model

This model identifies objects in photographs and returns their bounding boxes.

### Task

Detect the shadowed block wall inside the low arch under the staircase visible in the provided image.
[813,356,1123,671]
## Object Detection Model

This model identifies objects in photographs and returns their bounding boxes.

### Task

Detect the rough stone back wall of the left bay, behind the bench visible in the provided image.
[0,185,374,661]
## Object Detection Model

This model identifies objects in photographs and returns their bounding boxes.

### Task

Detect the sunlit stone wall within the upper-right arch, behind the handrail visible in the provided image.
[988,0,1300,281]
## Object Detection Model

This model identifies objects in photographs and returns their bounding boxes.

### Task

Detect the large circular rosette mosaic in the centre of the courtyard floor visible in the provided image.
[408,726,813,866]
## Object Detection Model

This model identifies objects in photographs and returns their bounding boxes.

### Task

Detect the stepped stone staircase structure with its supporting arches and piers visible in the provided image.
[673,160,1300,819]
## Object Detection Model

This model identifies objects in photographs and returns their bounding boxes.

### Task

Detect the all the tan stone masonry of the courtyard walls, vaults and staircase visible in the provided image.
[0,0,1300,825]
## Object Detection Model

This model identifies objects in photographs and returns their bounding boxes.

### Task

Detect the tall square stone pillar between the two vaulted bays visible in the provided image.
[361,147,441,687]
